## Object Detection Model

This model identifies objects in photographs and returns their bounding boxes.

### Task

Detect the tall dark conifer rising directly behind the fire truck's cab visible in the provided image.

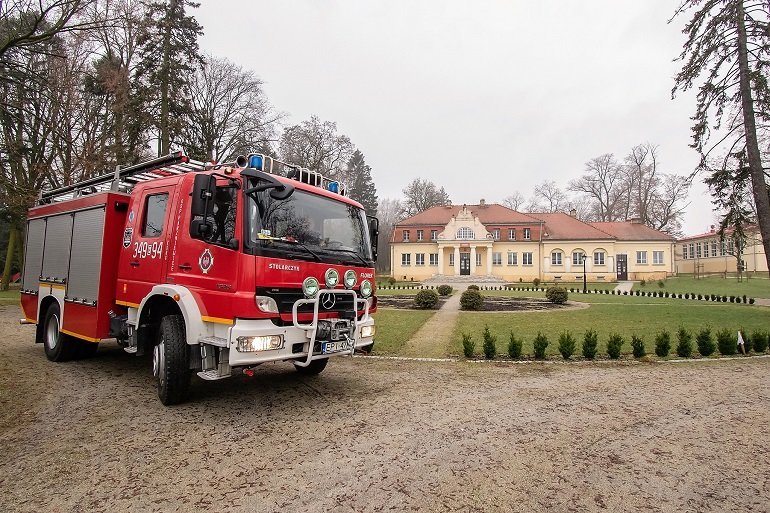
[136,0,203,155]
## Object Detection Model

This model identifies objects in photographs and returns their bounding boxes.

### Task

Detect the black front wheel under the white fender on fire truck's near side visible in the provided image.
[152,315,191,406]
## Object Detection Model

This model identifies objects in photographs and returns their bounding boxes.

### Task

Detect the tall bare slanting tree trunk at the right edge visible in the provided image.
[737,0,770,276]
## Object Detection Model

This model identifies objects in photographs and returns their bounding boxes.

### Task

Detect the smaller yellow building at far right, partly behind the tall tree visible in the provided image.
[675,225,767,274]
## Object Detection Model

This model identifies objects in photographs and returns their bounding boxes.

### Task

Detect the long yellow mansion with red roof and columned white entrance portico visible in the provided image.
[390,201,673,282]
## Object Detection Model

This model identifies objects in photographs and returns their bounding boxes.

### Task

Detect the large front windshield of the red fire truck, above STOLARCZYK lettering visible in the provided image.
[247,189,373,266]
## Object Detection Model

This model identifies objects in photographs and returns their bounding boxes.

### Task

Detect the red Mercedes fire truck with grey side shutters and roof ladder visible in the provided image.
[21,152,378,405]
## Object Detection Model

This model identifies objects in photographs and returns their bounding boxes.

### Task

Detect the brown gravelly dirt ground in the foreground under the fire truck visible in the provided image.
[0,307,770,512]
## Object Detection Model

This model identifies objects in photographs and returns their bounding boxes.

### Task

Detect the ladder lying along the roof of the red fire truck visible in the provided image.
[37,151,211,205]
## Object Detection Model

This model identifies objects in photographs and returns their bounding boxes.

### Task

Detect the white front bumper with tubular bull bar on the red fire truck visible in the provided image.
[228,289,374,367]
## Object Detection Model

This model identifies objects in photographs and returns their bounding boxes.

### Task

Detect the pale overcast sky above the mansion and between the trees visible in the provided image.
[192,0,714,234]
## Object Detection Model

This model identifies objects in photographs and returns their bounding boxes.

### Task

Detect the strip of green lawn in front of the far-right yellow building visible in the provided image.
[634,276,770,298]
